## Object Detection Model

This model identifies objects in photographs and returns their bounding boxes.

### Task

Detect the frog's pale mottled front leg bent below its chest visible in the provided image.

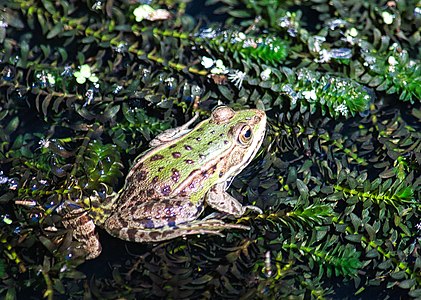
[205,183,263,218]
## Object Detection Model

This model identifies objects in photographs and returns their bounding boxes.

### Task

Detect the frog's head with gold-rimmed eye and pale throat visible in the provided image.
[210,106,266,182]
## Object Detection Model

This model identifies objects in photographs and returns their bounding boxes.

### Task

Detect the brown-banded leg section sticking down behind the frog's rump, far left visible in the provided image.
[62,208,102,259]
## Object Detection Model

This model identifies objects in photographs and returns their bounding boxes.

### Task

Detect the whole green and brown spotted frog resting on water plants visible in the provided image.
[62,105,266,259]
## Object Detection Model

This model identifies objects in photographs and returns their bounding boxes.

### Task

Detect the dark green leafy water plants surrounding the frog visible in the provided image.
[0,0,421,299]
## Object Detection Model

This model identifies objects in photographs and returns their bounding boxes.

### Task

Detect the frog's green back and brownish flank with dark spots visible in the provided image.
[121,120,232,205]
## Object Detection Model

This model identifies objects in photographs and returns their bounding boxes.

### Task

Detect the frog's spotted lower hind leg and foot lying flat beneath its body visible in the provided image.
[107,219,250,242]
